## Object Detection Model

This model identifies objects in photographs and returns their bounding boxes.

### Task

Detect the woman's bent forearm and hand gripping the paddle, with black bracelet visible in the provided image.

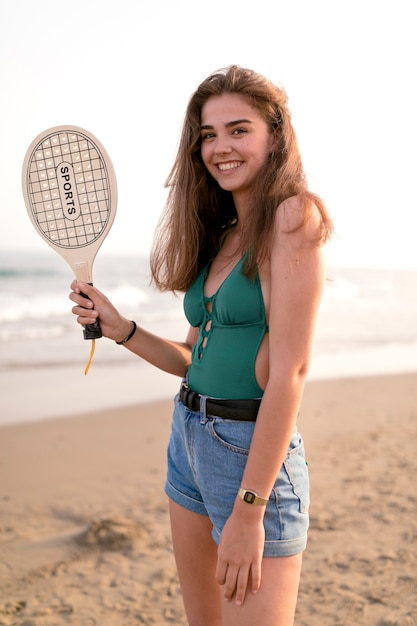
[70,280,197,376]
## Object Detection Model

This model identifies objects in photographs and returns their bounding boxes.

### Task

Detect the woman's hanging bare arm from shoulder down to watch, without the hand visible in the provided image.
[237,200,325,497]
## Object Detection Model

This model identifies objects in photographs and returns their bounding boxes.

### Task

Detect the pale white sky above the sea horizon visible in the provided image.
[0,0,417,269]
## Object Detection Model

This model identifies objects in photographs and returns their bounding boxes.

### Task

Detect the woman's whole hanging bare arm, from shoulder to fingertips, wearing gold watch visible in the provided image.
[217,198,325,603]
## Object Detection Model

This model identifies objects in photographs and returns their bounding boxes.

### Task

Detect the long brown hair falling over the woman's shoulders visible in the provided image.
[151,65,332,291]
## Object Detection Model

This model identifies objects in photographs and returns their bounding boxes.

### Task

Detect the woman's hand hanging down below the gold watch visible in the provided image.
[216,508,265,605]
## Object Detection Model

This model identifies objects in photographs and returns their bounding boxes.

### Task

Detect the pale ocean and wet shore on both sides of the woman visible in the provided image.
[0,250,417,423]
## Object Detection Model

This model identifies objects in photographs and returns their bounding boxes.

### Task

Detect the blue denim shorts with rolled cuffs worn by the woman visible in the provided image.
[165,396,310,557]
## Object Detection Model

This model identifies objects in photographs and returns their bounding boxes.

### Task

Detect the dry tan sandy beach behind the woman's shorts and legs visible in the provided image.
[0,374,417,626]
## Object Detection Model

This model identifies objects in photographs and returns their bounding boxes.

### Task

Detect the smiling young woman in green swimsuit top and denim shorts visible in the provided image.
[70,66,332,626]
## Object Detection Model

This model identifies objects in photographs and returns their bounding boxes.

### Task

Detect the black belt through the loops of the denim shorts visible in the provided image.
[179,383,261,422]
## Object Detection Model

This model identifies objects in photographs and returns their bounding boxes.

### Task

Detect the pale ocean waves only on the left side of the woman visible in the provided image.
[0,246,182,370]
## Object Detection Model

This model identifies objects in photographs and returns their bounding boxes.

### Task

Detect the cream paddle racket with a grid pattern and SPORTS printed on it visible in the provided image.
[22,126,117,368]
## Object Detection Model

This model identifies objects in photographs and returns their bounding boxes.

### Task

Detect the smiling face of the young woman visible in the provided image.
[201,93,274,207]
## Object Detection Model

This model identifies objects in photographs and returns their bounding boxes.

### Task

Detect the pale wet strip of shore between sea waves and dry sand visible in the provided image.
[0,344,417,428]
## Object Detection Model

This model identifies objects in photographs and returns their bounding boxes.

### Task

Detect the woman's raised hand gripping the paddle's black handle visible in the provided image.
[69,280,132,341]
